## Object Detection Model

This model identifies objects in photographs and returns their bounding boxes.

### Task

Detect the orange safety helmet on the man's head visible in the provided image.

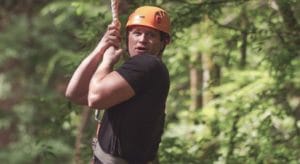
[126,6,171,36]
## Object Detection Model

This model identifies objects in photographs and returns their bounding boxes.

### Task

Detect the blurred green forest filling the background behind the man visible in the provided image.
[0,0,300,164]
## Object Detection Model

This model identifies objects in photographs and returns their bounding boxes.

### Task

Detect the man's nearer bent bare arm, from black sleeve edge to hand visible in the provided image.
[88,47,135,109]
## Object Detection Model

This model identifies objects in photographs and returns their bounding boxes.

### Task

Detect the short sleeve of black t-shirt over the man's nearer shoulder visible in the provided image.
[116,55,159,93]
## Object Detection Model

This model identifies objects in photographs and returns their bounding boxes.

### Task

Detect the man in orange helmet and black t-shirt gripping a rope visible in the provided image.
[66,6,170,164]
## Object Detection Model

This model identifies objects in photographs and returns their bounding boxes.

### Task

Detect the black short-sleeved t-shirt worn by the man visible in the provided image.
[99,55,170,164]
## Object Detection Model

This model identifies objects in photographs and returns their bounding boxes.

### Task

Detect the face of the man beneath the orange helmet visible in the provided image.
[128,26,165,57]
